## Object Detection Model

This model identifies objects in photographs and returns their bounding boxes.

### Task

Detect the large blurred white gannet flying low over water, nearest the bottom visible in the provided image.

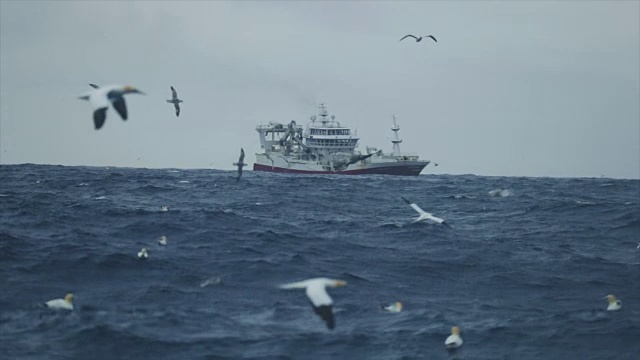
[280,278,347,329]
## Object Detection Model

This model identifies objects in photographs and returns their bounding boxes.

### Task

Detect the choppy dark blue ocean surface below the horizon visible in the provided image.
[0,165,640,359]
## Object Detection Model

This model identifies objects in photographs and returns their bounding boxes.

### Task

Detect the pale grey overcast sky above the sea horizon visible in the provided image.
[0,0,640,179]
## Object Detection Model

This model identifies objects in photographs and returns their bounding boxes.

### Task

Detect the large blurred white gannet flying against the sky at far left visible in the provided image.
[78,85,144,130]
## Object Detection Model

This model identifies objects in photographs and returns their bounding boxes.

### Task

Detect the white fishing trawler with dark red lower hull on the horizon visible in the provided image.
[253,104,429,176]
